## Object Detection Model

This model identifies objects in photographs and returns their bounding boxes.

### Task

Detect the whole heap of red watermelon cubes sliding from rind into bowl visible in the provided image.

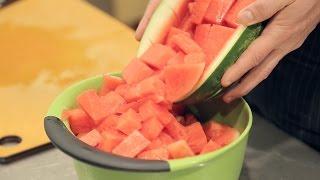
[63,0,247,160]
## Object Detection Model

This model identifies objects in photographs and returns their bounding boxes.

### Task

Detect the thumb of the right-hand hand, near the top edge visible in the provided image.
[237,0,295,26]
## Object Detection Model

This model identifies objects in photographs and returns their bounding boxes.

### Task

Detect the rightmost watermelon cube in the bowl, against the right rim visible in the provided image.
[212,126,239,146]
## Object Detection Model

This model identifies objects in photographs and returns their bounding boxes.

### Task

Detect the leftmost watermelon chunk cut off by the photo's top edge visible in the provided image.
[190,0,211,24]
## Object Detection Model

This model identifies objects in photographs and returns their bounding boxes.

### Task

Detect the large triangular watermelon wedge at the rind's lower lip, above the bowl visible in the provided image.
[164,63,205,102]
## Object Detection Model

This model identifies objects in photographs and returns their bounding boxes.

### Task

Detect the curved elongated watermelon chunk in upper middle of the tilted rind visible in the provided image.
[170,34,203,54]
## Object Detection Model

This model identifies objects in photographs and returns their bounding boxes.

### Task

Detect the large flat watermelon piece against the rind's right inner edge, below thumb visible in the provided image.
[201,24,235,65]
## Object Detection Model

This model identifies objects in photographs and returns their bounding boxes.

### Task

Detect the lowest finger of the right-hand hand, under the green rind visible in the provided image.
[223,49,286,103]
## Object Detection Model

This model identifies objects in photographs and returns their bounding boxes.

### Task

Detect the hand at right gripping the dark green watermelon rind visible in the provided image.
[222,0,320,102]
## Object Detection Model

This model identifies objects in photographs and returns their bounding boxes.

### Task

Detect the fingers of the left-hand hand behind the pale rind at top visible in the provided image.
[135,0,161,41]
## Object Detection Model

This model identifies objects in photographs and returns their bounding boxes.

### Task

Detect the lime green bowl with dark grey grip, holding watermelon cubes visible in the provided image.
[44,76,252,180]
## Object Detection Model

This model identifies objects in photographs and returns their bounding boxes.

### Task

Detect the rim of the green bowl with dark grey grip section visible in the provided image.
[44,74,252,172]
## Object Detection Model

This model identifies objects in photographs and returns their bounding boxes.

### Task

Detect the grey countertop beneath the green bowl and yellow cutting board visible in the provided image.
[0,114,320,180]
